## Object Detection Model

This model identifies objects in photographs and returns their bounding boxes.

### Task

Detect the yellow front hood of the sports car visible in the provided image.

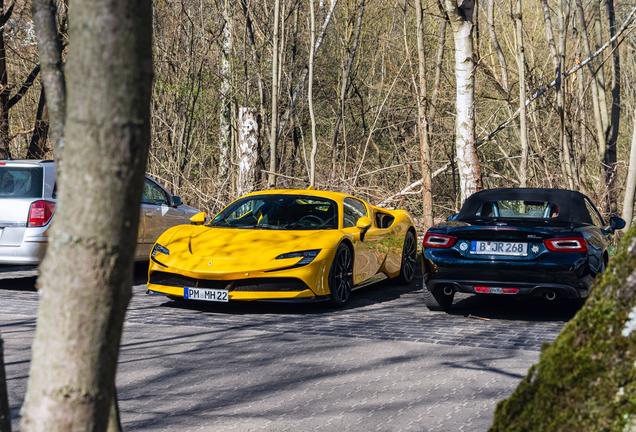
[158,225,343,274]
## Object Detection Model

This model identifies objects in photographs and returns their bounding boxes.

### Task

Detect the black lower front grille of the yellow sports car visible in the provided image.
[149,272,309,292]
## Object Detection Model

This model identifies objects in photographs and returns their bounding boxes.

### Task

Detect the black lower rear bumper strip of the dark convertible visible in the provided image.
[426,279,589,298]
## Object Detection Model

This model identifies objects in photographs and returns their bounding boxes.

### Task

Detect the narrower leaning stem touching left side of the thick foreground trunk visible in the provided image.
[31,0,66,168]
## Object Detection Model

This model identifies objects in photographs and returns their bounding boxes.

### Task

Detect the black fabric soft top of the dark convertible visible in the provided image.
[457,188,593,224]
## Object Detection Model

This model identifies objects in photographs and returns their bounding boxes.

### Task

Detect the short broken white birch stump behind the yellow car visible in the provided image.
[237,108,261,196]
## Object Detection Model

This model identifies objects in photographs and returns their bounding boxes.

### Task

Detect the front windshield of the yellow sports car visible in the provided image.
[207,194,338,230]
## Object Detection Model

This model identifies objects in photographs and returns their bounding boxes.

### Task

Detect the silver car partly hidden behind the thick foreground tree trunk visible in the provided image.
[0,160,199,265]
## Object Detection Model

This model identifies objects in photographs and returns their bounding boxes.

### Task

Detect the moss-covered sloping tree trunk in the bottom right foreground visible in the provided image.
[490,227,636,432]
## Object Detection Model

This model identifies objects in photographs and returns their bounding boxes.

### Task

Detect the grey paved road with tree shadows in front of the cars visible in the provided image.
[0,266,580,432]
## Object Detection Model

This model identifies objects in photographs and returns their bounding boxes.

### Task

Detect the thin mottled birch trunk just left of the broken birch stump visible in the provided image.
[219,0,232,176]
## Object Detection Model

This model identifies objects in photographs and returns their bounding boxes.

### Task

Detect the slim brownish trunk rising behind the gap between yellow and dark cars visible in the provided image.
[415,0,433,230]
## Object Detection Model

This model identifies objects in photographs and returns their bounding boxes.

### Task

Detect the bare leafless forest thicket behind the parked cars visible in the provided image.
[0,0,636,231]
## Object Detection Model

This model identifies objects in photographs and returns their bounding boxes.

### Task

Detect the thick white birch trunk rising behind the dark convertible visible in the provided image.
[444,0,482,202]
